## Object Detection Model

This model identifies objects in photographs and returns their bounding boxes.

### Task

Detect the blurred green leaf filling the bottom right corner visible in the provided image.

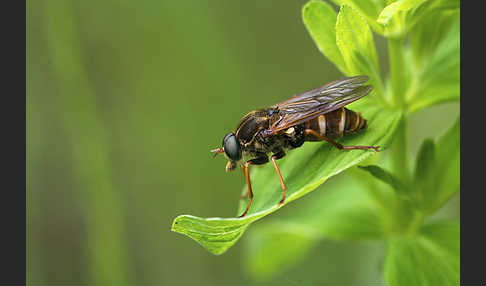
[384,222,460,286]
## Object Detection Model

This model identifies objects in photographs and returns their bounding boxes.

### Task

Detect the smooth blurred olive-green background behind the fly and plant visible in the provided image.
[26,0,459,286]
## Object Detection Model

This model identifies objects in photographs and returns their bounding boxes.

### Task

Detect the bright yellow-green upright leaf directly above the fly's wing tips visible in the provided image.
[336,5,383,95]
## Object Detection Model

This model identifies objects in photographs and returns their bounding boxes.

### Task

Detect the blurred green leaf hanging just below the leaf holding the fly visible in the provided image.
[245,173,390,279]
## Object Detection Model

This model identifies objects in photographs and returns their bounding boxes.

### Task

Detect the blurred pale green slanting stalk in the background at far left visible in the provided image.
[42,0,133,286]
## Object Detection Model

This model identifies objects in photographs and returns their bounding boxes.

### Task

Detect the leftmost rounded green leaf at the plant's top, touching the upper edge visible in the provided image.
[302,0,348,74]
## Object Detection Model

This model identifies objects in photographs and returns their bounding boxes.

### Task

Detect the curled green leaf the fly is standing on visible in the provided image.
[172,98,402,254]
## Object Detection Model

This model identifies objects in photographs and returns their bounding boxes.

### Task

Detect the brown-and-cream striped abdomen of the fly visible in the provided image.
[304,107,366,141]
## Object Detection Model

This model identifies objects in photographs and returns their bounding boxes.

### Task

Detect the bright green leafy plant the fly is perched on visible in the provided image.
[172,0,460,285]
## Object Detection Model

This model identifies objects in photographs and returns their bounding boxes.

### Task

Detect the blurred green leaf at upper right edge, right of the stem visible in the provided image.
[407,17,460,112]
